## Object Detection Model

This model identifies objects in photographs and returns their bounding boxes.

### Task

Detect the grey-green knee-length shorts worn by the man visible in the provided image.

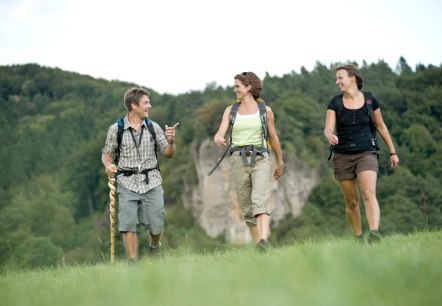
[117,185,166,235]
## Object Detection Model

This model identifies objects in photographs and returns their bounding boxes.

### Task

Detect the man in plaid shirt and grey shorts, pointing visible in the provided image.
[101,88,179,262]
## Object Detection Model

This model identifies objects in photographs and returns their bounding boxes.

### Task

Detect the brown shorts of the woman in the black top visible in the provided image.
[333,151,378,181]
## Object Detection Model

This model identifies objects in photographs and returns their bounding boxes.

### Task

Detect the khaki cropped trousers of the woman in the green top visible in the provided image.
[230,152,270,226]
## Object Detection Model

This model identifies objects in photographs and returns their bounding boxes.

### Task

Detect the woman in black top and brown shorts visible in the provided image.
[324,65,399,242]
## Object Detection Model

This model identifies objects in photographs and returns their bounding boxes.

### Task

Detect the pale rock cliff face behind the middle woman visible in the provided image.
[183,139,319,244]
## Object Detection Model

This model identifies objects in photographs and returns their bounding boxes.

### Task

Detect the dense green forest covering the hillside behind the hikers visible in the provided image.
[0,58,442,269]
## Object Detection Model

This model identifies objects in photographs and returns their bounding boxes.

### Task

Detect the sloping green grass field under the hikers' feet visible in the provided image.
[0,231,442,306]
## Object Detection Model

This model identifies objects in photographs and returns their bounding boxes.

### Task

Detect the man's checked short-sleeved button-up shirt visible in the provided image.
[102,115,168,194]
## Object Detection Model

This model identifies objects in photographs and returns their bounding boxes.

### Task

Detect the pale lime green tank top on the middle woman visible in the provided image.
[232,111,266,148]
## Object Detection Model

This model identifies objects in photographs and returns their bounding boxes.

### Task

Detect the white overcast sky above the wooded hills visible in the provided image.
[0,0,442,94]
